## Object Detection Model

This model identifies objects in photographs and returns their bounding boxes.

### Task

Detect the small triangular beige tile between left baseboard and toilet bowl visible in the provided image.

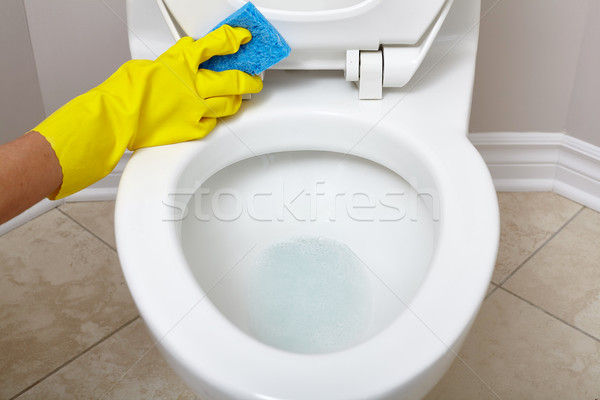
[59,201,117,249]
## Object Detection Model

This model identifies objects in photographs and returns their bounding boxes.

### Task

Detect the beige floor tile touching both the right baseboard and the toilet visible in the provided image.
[492,192,582,283]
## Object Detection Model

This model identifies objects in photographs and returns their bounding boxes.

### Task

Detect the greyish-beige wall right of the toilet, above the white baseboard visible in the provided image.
[470,0,600,146]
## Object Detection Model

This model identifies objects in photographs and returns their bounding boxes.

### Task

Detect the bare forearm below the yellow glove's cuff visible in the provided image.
[0,132,62,223]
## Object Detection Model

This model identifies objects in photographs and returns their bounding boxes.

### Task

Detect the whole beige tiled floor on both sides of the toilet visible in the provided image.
[8,193,600,400]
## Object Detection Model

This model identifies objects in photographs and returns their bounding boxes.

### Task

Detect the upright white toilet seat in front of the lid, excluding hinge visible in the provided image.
[157,0,452,69]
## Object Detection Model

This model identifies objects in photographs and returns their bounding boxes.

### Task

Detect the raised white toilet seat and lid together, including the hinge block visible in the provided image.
[155,0,454,99]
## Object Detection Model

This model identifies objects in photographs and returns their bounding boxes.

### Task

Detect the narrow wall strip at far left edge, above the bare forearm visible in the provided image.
[0,0,44,144]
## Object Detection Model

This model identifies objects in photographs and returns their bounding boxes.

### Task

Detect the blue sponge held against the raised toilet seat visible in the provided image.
[200,2,291,75]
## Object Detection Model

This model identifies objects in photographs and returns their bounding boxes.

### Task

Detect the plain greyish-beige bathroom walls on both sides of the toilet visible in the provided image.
[0,0,600,146]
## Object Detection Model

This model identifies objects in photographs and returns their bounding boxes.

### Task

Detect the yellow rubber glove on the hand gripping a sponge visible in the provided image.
[33,25,262,200]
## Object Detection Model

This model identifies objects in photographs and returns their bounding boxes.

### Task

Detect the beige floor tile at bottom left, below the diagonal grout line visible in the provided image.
[18,318,195,400]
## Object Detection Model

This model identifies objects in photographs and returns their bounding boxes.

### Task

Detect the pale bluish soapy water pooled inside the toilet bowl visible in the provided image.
[248,236,371,353]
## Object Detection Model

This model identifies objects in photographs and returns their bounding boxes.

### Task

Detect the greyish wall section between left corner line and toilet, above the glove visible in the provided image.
[25,0,130,115]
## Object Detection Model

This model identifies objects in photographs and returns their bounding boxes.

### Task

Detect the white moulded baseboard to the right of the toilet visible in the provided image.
[469,132,600,211]
